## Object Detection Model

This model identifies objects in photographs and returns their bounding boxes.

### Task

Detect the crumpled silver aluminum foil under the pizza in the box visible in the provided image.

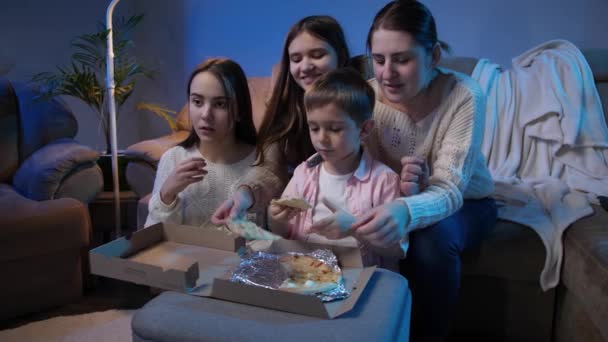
[230,249,350,302]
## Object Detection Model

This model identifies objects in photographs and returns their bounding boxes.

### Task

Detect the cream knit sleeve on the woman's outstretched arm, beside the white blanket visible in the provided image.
[400,80,491,231]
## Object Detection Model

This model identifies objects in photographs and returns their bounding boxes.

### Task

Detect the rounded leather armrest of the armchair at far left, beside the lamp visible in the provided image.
[13,139,103,201]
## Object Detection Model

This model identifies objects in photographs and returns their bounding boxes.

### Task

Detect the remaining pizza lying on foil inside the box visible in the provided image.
[279,254,342,294]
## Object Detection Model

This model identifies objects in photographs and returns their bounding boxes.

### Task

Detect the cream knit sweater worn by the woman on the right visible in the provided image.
[367,71,494,231]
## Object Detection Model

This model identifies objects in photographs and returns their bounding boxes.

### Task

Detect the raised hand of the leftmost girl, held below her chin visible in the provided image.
[160,158,207,204]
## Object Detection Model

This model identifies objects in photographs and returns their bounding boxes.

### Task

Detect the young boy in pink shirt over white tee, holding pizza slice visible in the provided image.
[268,68,407,271]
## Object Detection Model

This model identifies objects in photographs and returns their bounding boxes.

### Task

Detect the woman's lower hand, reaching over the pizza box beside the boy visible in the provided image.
[352,201,409,248]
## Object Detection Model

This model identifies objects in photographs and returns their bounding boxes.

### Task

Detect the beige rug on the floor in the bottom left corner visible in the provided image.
[0,310,135,342]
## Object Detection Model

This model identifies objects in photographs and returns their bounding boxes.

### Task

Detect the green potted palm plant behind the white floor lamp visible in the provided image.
[32,15,175,191]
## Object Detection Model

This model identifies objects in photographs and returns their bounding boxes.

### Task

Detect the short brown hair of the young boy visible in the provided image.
[304,67,376,125]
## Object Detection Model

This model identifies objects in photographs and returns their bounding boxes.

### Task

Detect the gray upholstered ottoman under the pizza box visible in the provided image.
[131,269,412,342]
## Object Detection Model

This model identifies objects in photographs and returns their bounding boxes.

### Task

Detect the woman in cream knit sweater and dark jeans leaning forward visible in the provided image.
[353,1,496,341]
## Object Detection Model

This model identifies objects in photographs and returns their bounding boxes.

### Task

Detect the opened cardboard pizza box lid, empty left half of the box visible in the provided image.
[89,223,245,292]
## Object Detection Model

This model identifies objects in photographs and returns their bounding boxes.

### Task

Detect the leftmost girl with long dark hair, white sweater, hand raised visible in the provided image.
[145,58,256,226]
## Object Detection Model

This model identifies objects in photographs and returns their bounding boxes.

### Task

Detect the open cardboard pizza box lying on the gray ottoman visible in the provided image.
[89,223,375,319]
